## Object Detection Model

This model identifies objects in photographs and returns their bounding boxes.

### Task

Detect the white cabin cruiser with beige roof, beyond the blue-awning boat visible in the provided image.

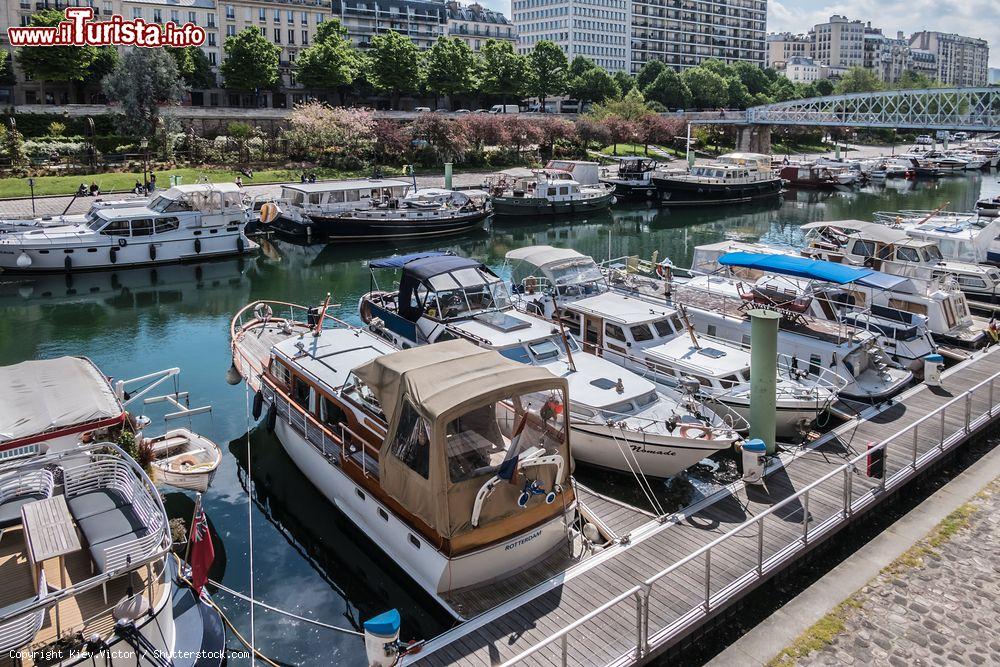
[801,220,1000,300]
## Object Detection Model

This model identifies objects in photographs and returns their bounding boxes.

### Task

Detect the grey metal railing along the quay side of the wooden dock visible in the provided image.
[501,373,1000,667]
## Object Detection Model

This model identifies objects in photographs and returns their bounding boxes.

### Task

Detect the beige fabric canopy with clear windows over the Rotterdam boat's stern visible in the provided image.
[354,340,570,538]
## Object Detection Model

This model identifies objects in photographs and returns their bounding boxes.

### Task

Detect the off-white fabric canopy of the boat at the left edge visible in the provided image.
[0,357,124,444]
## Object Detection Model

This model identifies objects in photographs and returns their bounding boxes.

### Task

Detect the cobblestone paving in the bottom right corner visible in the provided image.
[795,480,1000,667]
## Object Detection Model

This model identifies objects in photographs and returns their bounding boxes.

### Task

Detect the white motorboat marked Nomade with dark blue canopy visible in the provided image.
[360,253,738,477]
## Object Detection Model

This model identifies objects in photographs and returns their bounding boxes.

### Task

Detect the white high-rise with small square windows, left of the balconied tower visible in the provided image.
[511,0,631,72]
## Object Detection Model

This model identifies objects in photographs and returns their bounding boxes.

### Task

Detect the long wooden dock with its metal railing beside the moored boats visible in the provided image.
[404,348,1000,665]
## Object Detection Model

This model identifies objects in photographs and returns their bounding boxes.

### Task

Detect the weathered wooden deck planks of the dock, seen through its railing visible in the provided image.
[412,350,1000,665]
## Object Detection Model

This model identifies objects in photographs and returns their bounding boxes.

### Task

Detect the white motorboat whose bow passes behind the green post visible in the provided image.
[507,246,847,437]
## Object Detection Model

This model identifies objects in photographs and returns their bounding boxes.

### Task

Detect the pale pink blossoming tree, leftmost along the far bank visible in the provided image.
[285,101,375,164]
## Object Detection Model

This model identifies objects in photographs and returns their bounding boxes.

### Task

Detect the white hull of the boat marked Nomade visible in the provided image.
[570,421,735,477]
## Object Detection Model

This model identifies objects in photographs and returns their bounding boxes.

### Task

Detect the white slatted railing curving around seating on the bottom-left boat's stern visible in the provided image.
[0,442,171,634]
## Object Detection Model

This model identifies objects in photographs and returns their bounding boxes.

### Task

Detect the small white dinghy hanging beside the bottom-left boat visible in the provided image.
[146,428,222,493]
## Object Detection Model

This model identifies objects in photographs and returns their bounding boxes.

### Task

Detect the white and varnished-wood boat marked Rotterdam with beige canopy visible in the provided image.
[231,302,577,611]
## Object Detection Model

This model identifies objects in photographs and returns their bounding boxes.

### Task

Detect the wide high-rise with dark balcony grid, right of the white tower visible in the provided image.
[630,0,767,73]
